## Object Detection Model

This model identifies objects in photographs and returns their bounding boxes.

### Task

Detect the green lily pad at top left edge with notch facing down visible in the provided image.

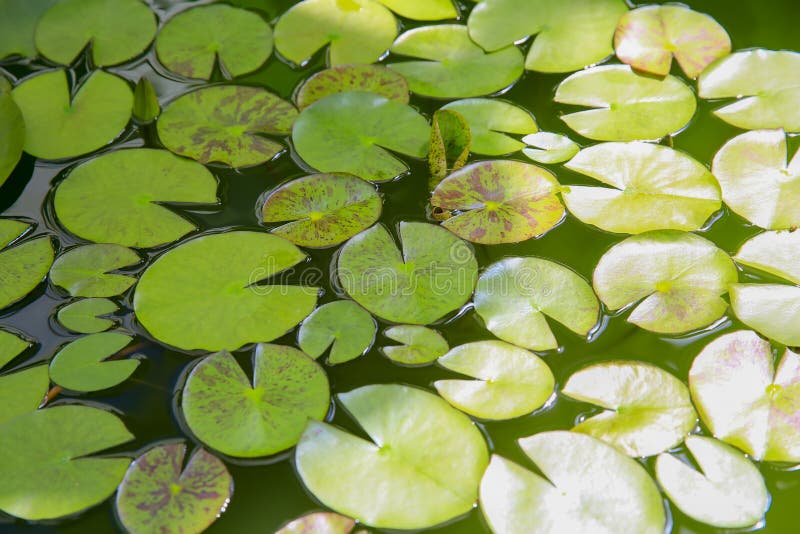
[35,0,157,67]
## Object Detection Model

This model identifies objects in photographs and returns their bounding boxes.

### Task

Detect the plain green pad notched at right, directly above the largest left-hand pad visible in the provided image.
[53,148,219,250]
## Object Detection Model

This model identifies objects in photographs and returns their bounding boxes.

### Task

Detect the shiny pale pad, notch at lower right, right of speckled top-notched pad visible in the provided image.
[475,258,600,350]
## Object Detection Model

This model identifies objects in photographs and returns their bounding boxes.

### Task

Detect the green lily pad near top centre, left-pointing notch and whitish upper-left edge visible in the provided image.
[389,24,524,98]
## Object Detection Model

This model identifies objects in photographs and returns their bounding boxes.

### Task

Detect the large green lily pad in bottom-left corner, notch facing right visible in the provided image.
[0,404,133,521]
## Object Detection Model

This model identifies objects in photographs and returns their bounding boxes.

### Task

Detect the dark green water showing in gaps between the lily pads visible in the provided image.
[0,0,800,534]
